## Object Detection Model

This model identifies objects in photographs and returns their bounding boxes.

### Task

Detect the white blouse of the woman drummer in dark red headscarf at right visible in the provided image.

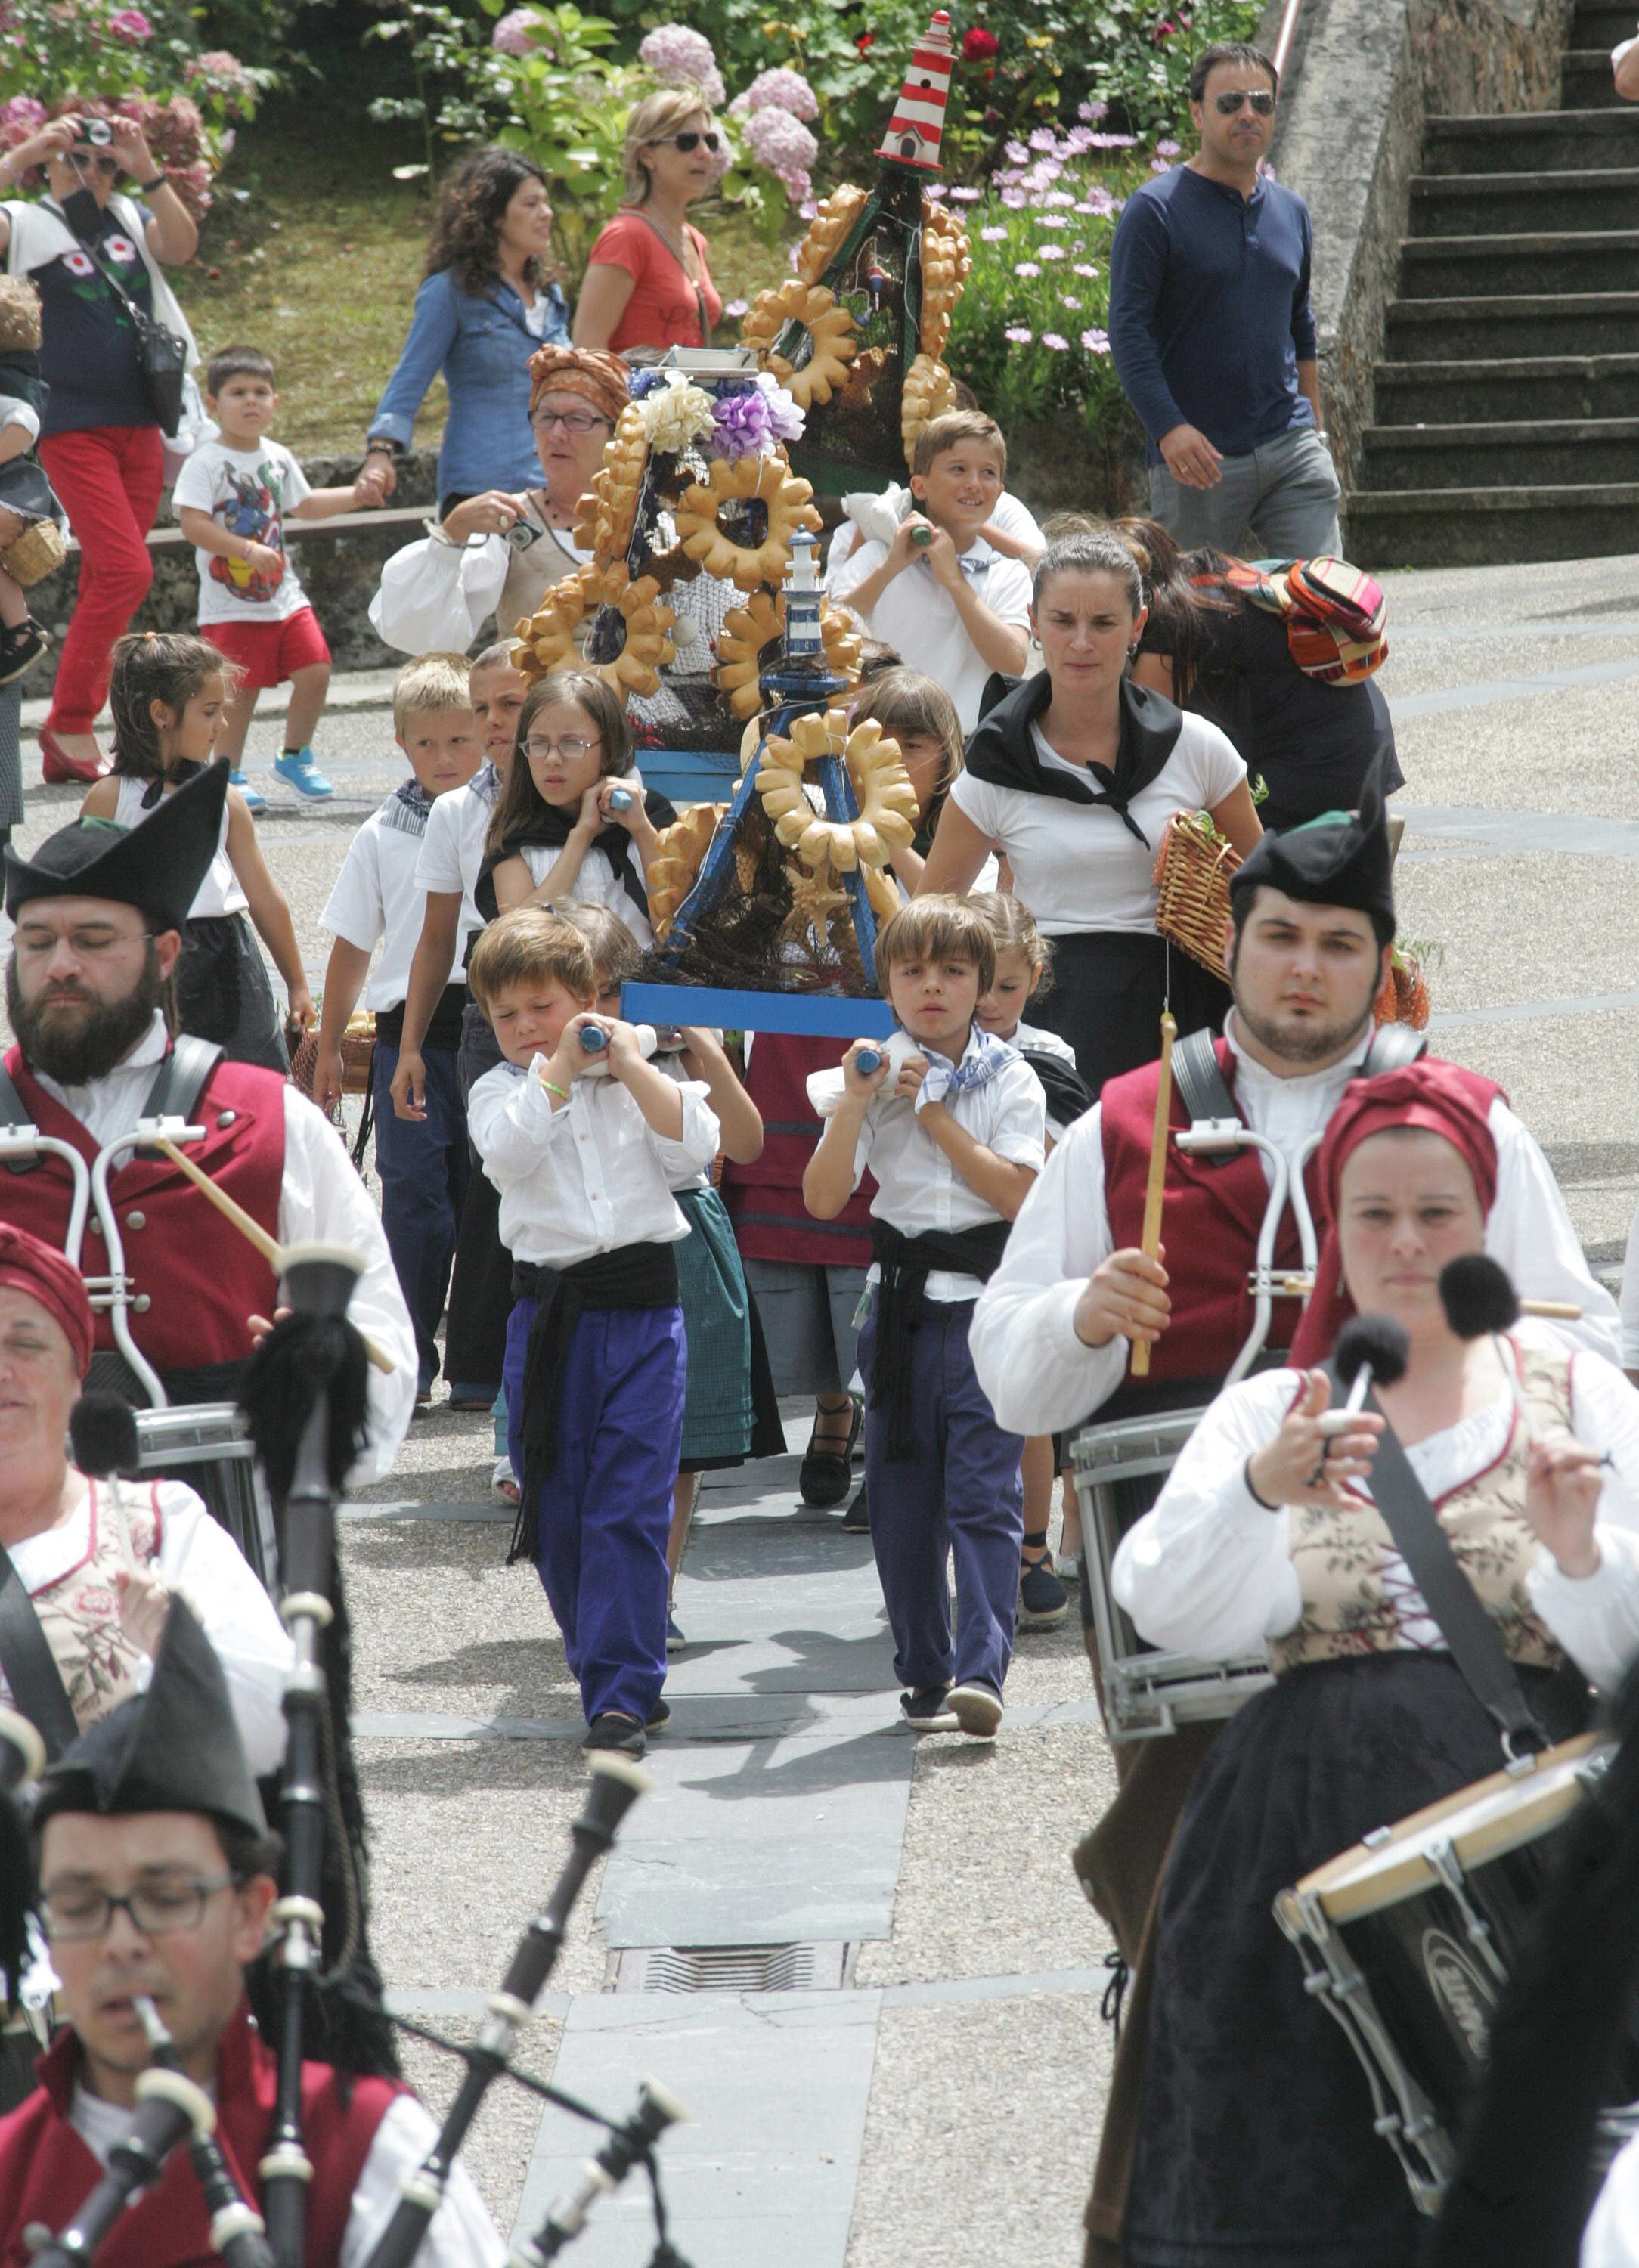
[1111,1354,1639,1692]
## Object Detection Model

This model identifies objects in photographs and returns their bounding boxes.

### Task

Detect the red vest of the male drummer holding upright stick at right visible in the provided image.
[1099,1039,1501,1381]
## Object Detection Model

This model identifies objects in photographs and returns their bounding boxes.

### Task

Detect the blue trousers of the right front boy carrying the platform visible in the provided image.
[859,1300,1024,1692]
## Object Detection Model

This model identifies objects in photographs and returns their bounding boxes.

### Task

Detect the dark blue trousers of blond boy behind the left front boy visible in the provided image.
[370,1041,467,1393]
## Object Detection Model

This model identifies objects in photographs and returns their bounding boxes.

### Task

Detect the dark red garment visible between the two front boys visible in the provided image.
[723,1032,877,1268]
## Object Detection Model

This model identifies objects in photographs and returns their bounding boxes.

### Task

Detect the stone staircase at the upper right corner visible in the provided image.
[1344,0,1639,567]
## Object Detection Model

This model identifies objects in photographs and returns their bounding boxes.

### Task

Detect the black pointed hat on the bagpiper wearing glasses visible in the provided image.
[32,1597,268,1835]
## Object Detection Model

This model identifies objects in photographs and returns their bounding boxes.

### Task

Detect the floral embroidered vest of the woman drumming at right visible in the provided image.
[1269,1343,1571,1672]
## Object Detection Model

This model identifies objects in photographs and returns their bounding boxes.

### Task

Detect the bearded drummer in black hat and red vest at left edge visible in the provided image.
[0,762,415,1479]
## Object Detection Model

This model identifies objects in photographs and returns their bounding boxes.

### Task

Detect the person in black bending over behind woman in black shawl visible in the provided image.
[1113,519,1405,832]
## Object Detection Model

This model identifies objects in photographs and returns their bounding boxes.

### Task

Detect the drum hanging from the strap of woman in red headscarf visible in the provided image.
[1274,1733,1639,2214]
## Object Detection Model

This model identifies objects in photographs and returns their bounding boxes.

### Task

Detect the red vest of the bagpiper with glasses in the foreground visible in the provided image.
[0,2000,406,2268]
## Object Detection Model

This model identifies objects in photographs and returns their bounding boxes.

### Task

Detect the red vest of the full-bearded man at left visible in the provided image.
[0,1048,286,1372]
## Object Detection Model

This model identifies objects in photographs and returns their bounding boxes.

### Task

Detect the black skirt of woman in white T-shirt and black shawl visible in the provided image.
[1029,930,1231,1102]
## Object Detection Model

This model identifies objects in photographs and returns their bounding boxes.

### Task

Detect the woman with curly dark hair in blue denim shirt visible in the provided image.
[363,150,569,519]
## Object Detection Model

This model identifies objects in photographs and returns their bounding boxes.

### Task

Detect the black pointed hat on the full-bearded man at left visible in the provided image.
[7,758,231,930]
